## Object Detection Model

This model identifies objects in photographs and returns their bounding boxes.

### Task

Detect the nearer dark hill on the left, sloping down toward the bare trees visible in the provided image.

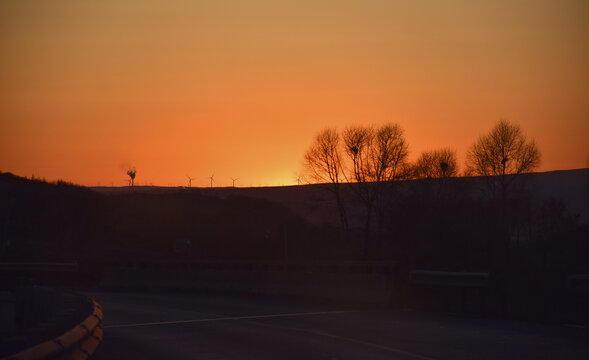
[0,174,344,261]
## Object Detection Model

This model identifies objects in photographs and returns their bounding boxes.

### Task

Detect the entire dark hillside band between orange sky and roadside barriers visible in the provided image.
[0,169,589,271]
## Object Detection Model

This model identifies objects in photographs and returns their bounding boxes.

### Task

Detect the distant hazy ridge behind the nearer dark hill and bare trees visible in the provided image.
[92,169,589,226]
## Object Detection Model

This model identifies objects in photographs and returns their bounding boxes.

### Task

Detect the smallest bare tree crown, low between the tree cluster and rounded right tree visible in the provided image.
[413,148,458,179]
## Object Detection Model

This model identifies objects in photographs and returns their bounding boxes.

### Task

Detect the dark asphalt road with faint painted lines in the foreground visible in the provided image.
[90,293,589,360]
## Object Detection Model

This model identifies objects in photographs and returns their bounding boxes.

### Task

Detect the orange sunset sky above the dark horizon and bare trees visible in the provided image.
[0,0,589,186]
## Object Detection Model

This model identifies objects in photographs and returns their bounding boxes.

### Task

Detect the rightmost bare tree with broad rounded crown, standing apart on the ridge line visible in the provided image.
[466,119,541,199]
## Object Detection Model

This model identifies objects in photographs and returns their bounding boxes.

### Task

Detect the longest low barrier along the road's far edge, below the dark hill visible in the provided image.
[101,261,396,306]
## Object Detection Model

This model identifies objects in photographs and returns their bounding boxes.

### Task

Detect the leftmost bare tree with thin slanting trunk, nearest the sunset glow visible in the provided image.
[304,128,348,230]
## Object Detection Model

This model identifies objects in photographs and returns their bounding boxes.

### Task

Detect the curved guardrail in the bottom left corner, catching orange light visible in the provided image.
[2,297,103,360]
